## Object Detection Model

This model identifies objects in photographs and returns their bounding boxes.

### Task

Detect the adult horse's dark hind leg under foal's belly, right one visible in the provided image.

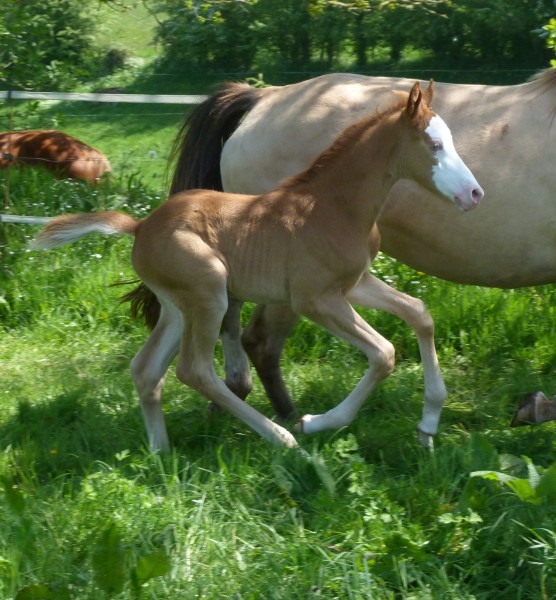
[241,304,299,421]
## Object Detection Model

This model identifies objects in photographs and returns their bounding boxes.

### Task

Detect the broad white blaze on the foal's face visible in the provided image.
[425,115,484,210]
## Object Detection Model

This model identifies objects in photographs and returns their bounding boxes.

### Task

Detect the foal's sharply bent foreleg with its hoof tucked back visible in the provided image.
[295,290,395,433]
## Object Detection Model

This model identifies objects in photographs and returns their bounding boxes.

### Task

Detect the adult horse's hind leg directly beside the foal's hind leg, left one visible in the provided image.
[220,297,253,400]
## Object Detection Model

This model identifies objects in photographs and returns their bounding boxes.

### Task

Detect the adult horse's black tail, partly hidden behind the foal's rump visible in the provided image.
[126,83,265,329]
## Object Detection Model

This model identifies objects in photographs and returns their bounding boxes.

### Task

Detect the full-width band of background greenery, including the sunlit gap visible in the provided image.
[0,0,553,92]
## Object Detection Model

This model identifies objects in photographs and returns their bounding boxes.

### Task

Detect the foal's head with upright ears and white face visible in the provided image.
[402,80,484,211]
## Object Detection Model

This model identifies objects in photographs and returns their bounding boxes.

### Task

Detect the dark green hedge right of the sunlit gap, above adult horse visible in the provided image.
[149,0,553,71]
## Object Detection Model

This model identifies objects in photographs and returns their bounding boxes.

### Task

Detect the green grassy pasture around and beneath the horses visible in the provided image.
[0,3,556,600]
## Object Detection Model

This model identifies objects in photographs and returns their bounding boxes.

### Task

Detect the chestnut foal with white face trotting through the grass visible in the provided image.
[34,83,483,449]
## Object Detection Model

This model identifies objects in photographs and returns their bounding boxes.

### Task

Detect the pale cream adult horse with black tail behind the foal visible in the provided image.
[165,69,556,428]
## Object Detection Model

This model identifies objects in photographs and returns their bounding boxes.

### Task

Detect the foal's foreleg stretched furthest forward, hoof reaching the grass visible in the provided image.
[346,273,447,446]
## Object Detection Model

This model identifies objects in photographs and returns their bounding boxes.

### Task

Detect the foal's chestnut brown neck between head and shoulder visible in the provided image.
[282,102,403,235]
